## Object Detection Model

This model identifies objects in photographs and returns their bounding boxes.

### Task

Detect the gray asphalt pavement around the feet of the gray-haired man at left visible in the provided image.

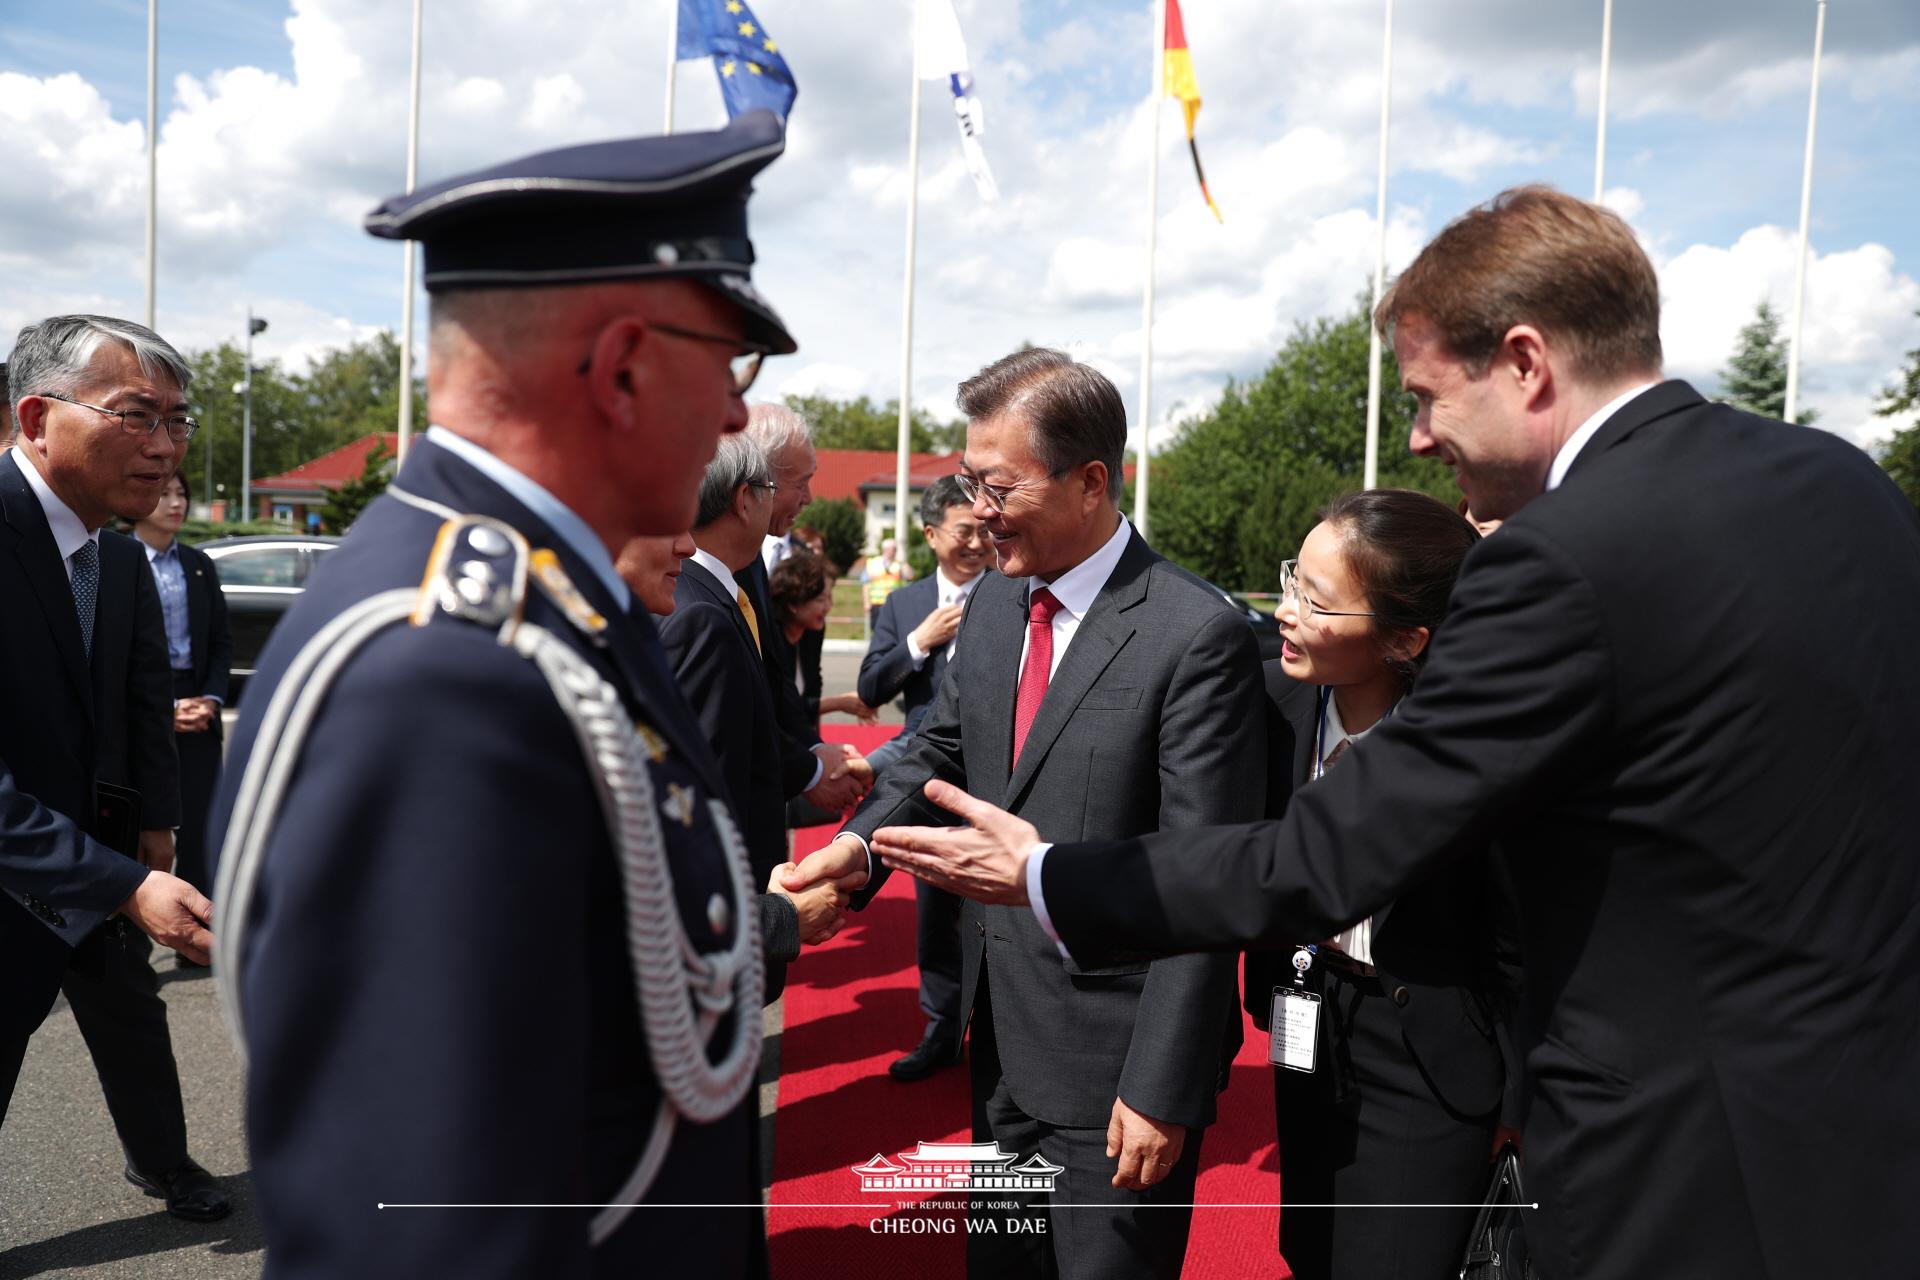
[0,652,900,1280]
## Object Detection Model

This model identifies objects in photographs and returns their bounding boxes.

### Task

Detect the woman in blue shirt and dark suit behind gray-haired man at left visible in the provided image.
[132,472,234,909]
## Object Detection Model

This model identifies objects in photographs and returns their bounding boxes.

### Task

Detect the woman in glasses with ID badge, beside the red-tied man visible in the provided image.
[1246,489,1517,1280]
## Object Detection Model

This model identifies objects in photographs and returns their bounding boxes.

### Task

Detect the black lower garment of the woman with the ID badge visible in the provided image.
[1273,965,1498,1280]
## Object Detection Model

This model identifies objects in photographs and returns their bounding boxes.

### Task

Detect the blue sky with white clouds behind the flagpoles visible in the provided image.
[0,0,1920,450]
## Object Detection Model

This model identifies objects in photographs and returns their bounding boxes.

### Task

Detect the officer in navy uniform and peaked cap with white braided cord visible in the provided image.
[215,113,795,1280]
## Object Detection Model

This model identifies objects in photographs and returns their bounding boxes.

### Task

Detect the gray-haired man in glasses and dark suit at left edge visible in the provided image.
[0,317,228,1221]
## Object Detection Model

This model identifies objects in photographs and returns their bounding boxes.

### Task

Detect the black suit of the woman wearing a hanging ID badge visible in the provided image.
[1246,662,1521,1280]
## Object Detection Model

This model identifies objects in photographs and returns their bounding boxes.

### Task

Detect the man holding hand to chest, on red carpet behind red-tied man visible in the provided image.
[858,476,993,1080]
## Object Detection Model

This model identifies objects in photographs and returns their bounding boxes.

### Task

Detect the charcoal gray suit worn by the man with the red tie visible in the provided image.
[849,533,1265,1276]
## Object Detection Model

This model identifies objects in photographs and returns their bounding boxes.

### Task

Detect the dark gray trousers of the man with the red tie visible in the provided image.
[966,969,1206,1280]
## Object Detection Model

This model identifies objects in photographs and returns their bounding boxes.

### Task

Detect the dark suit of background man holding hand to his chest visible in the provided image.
[858,574,979,1048]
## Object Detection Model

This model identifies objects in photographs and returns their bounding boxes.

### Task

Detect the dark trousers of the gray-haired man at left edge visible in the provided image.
[0,913,186,1173]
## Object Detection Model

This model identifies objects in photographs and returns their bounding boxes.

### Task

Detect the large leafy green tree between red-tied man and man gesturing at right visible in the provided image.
[1152,301,1459,591]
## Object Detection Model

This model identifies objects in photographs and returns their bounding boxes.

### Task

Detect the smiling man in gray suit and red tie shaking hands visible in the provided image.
[789,349,1267,1276]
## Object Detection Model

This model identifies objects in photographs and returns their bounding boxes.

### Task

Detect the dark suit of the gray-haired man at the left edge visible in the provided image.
[0,457,186,1174]
